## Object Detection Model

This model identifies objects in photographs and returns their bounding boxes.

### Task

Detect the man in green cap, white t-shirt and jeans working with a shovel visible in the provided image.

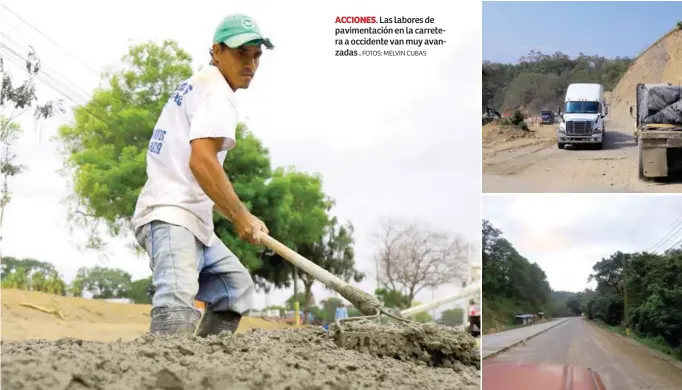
[133,14,273,337]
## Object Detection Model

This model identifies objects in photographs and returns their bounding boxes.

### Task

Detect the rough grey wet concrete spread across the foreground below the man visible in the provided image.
[1,328,481,390]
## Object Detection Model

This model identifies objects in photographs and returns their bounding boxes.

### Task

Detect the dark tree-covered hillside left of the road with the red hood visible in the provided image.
[482,220,552,333]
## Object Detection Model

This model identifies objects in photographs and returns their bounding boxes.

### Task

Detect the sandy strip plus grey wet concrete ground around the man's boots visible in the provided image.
[2,289,481,390]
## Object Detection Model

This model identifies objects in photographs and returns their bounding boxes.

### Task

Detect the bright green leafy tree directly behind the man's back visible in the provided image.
[58,40,192,248]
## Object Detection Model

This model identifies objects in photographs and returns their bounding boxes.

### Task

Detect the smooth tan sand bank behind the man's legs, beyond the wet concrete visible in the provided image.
[1,289,291,341]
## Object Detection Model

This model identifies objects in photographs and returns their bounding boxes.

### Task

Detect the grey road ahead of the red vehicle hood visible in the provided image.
[483,318,682,390]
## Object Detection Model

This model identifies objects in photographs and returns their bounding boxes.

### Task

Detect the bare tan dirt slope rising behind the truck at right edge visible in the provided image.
[606,28,682,128]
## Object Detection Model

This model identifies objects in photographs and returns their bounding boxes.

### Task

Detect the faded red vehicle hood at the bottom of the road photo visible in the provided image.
[483,360,606,390]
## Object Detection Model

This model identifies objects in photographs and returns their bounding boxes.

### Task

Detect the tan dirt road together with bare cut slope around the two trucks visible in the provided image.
[483,30,682,193]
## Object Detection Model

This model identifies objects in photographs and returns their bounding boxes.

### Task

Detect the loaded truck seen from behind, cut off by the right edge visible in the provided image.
[630,83,682,180]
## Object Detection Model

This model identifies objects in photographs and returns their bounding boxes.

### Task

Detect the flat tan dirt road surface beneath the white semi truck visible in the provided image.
[483,123,682,193]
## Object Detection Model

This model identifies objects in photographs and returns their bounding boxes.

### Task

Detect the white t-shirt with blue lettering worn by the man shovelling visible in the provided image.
[132,66,238,246]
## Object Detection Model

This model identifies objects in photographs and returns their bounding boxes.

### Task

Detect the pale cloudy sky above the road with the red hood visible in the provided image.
[483,194,682,291]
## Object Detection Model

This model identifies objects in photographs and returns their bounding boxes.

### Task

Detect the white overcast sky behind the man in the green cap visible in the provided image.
[0,0,481,307]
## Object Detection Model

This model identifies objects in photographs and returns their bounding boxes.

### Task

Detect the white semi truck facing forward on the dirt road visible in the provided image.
[557,83,609,149]
